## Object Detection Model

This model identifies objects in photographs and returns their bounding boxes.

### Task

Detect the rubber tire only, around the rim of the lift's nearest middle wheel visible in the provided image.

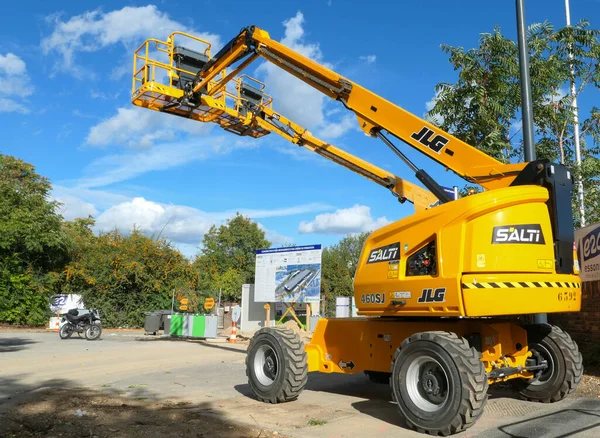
[390,332,488,436]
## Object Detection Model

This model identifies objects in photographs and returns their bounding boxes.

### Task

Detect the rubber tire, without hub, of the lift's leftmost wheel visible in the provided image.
[246,327,308,403]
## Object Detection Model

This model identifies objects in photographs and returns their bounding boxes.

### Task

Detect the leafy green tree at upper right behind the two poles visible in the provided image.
[427,20,600,223]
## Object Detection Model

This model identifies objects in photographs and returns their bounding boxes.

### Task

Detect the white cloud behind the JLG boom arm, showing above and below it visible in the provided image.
[257,11,355,138]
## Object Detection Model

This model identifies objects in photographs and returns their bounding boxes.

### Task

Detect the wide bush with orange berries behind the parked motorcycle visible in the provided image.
[60,222,197,327]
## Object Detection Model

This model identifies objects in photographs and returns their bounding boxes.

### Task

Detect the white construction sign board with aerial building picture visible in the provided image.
[254,245,321,303]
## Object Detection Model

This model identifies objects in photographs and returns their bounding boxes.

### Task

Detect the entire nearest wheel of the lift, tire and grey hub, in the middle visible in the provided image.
[390,332,488,436]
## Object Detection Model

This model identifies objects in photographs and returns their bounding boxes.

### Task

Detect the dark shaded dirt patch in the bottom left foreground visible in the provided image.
[0,388,283,438]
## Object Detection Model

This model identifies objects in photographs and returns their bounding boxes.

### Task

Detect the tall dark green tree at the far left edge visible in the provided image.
[0,155,68,325]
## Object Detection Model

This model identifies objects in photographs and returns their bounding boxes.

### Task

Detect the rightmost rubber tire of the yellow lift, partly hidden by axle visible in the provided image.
[514,324,583,403]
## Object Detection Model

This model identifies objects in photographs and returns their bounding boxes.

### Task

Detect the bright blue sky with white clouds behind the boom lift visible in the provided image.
[0,0,600,255]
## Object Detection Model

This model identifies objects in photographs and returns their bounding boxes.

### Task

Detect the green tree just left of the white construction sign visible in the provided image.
[194,213,271,300]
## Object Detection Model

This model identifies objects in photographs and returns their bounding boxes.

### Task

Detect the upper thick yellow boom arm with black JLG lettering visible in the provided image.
[189,26,525,189]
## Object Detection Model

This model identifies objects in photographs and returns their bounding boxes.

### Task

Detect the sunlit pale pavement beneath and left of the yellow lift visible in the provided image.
[0,331,600,438]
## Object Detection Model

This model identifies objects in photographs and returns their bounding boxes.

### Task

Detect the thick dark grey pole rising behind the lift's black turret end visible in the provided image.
[516,0,548,324]
